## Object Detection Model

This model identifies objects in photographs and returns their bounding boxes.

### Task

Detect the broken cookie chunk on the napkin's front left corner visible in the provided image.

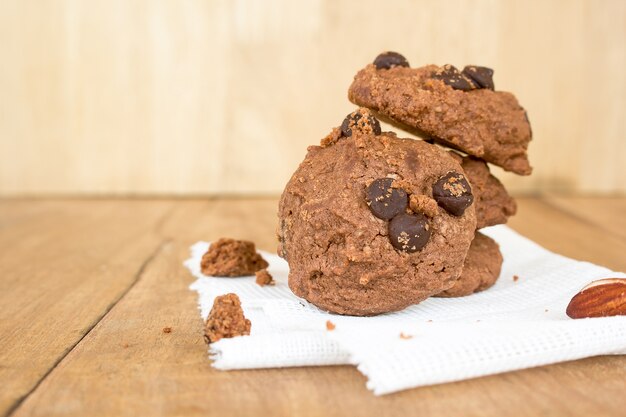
[204,293,251,343]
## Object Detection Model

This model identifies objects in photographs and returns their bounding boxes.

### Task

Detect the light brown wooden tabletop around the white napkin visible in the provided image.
[0,197,626,417]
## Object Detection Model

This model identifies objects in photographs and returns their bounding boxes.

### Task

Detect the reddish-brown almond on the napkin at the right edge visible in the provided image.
[565,278,626,319]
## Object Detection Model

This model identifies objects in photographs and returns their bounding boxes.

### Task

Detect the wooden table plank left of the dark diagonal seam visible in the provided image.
[0,200,171,415]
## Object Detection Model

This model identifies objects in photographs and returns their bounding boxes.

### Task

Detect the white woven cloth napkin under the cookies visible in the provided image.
[185,226,626,395]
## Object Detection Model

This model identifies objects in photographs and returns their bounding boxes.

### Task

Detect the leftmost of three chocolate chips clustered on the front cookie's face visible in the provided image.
[365,178,409,220]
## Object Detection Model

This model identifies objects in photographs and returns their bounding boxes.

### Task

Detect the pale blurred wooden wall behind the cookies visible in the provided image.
[0,0,626,195]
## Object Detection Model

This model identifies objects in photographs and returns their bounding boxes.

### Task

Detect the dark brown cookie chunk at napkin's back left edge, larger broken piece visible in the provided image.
[201,238,269,277]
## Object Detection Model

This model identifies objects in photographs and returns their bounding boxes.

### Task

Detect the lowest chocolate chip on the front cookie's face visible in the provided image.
[389,213,430,253]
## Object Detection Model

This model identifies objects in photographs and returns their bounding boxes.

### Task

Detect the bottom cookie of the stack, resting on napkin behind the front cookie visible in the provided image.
[436,232,502,297]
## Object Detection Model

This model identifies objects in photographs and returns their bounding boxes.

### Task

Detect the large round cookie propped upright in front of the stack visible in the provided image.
[278,114,476,315]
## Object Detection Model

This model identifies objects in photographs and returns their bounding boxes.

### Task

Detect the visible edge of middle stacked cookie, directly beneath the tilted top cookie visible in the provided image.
[456,155,517,229]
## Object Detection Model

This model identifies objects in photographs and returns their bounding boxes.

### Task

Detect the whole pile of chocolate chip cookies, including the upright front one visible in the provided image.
[278,52,532,315]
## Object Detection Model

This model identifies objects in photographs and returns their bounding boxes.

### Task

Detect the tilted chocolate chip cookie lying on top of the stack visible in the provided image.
[348,52,532,175]
